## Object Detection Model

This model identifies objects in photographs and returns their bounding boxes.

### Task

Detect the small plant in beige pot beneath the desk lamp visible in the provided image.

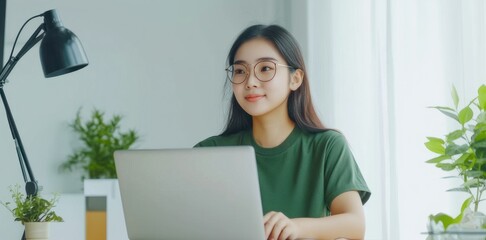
[0,185,63,239]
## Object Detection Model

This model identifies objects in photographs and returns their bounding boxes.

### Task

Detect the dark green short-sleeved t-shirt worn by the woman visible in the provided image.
[195,127,371,218]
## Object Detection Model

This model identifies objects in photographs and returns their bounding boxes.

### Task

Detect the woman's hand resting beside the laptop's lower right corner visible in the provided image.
[263,212,299,240]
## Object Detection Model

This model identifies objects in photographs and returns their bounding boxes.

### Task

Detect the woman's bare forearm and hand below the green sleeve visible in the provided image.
[264,191,365,240]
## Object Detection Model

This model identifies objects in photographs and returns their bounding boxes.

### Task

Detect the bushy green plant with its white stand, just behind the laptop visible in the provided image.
[61,109,139,240]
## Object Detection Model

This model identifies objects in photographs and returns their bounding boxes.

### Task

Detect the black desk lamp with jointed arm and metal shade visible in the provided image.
[0,9,88,228]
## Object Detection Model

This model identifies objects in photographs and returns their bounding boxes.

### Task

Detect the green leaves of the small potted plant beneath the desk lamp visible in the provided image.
[0,185,63,224]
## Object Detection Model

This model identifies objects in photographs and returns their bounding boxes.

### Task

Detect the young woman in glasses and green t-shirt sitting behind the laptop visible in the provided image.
[196,25,370,240]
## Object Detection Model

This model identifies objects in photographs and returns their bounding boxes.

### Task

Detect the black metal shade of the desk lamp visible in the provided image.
[40,10,88,78]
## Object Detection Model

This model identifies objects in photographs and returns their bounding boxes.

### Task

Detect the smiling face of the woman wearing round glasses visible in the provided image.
[232,38,300,117]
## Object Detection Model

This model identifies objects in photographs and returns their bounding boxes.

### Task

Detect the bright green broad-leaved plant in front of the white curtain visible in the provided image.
[425,85,486,230]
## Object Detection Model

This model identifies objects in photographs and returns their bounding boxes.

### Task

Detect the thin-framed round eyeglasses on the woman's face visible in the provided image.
[226,61,294,84]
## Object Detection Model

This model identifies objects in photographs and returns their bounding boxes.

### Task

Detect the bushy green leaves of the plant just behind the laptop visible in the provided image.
[61,109,139,179]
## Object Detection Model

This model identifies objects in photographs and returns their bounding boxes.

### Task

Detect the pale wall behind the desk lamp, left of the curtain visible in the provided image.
[0,0,288,239]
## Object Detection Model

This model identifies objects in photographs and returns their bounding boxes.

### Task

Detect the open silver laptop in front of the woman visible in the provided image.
[115,146,265,240]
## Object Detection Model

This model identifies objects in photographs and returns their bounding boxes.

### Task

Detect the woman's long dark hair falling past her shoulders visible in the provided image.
[221,25,326,135]
